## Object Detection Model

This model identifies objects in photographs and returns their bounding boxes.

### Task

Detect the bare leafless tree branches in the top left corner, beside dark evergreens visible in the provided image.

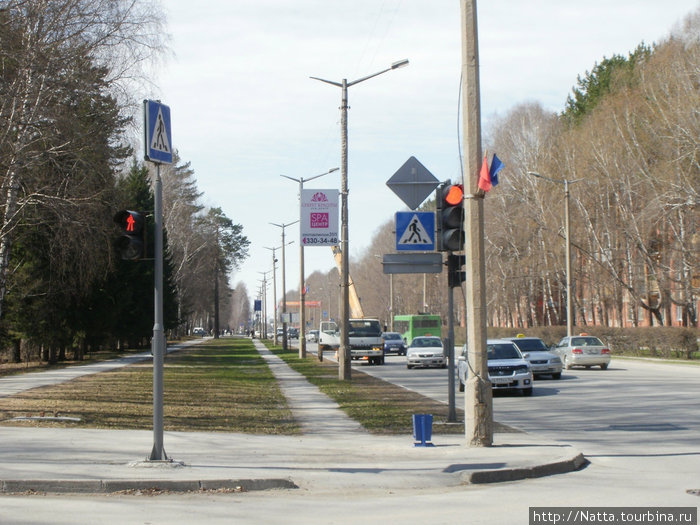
[0,0,162,320]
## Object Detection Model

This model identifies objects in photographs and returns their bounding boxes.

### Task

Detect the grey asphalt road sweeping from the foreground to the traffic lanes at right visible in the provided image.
[0,338,700,525]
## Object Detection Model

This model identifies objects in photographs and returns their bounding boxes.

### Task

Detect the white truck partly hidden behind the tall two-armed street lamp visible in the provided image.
[318,319,384,365]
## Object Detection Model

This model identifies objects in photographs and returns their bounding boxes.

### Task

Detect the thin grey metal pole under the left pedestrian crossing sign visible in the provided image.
[148,163,168,461]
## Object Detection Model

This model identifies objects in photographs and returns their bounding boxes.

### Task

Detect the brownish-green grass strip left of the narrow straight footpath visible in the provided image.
[0,338,300,435]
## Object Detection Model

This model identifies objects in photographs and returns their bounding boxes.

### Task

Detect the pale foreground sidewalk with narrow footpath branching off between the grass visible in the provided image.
[0,341,586,493]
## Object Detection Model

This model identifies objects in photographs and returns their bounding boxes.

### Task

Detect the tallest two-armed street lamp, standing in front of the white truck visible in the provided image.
[311,59,408,380]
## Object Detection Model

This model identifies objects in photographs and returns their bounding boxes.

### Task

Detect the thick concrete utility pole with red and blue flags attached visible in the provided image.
[460,0,493,447]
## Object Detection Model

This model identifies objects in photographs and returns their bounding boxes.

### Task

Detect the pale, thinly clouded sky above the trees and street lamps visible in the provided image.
[146,0,700,304]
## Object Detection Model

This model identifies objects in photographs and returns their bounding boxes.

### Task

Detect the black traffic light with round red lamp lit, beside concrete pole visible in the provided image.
[435,180,464,252]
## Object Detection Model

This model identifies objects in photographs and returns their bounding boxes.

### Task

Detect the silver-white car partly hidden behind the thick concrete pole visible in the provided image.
[457,339,533,396]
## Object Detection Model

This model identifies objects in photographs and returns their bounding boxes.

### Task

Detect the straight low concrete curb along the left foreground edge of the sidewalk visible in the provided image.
[0,478,299,494]
